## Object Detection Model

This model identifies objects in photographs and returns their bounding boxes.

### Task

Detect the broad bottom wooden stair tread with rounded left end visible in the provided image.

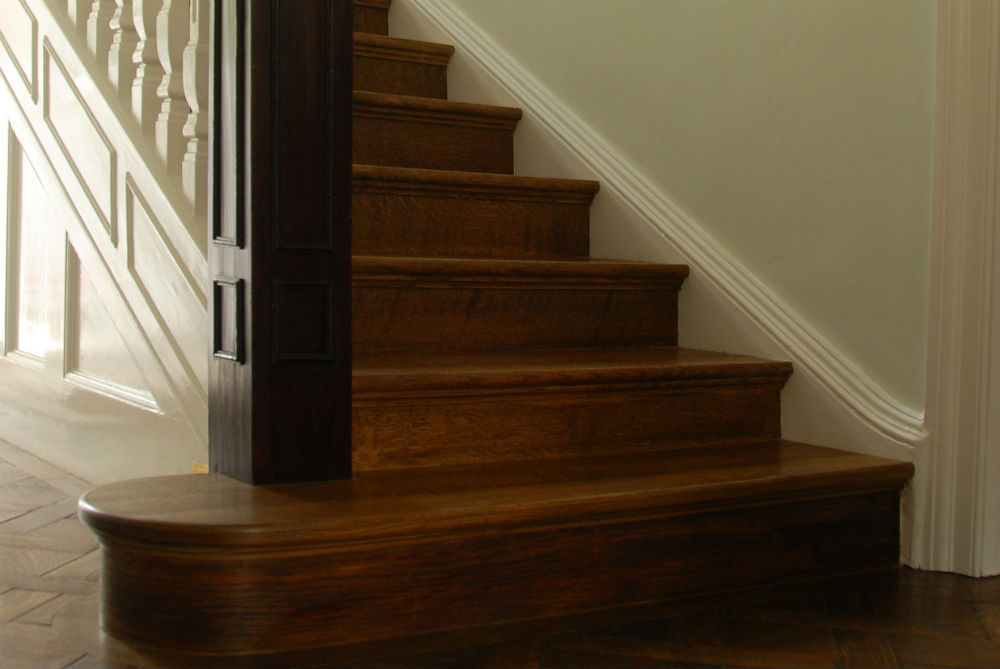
[80,440,913,548]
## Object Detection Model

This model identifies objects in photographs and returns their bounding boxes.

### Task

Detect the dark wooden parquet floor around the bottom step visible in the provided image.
[0,442,984,669]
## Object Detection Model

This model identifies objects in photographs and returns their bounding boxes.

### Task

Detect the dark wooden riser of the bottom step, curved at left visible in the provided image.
[97,491,899,652]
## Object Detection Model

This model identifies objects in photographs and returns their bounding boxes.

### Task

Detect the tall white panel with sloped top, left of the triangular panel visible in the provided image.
[14,144,65,361]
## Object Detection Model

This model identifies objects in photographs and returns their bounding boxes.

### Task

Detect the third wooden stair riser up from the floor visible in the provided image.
[352,284,677,353]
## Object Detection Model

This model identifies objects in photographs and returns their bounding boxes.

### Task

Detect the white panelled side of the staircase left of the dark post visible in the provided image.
[0,0,208,483]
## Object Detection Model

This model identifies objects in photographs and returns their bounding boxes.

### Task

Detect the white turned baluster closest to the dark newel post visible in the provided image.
[181,0,210,215]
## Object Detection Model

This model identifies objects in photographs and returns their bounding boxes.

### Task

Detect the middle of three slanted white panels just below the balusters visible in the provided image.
[42,43,117,243]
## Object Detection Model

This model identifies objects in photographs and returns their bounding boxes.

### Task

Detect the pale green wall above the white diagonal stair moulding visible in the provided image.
[452,0,936,409]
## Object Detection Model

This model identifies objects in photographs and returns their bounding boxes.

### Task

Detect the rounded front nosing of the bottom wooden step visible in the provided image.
[80,440,913,552]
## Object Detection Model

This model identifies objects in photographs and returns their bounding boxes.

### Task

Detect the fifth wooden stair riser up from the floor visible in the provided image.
[354,115,514,174]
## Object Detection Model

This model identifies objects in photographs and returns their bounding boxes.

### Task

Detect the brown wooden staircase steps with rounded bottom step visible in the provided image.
[81,0,912,664]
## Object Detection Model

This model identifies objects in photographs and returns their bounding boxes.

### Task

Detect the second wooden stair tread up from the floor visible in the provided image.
[353,346,792,393]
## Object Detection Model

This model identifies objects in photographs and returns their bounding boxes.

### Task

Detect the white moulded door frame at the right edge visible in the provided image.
[907,0,1000,576]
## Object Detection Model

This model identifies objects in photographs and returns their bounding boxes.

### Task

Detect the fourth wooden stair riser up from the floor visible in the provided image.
[352,190,590,258]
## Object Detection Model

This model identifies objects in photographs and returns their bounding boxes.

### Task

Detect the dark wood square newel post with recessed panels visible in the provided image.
[208,0,353,484]
